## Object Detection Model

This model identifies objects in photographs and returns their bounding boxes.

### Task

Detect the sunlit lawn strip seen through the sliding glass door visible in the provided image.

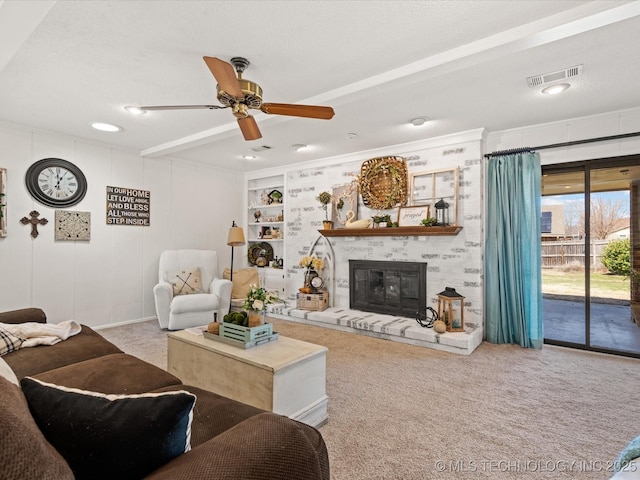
[542,269,630,300]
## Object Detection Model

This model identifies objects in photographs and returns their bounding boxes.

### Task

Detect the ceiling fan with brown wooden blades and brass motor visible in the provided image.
[139,57,334,140]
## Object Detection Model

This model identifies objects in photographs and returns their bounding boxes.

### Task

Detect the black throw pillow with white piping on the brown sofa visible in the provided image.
[20,377,196,480]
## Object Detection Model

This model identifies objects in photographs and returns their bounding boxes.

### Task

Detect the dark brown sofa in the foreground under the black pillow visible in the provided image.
[0,308,329,480]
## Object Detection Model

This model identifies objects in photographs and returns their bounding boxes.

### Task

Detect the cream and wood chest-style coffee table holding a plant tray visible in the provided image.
[167,330,328,427]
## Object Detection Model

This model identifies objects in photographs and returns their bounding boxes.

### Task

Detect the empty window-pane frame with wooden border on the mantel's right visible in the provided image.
[409,167,460,225]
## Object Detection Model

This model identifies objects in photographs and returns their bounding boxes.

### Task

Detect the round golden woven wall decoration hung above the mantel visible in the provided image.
[358,157,407,210]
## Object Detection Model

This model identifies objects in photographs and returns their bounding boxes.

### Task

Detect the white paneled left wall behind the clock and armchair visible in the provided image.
[0,125,243,326]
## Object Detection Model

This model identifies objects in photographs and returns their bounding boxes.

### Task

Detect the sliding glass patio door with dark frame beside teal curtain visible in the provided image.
[542,157,640,356]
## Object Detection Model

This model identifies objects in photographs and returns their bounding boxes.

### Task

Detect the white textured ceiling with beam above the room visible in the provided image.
[0,0,640,171]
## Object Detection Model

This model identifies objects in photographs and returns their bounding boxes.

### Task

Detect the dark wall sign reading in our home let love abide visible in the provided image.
[107,187,151,227]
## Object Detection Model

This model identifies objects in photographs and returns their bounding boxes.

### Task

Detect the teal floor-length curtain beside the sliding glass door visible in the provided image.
[485,152,544,348]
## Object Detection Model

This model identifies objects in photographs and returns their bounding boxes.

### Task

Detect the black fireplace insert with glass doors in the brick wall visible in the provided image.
[349,260,427,317]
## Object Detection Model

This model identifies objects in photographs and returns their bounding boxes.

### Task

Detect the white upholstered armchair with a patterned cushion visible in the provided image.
[153,250,231,330]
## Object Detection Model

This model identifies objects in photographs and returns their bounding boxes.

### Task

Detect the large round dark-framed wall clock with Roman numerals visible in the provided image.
[25,158,87,208]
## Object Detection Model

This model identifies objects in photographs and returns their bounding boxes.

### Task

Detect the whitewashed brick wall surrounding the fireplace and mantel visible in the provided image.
[278,133,484,352]
